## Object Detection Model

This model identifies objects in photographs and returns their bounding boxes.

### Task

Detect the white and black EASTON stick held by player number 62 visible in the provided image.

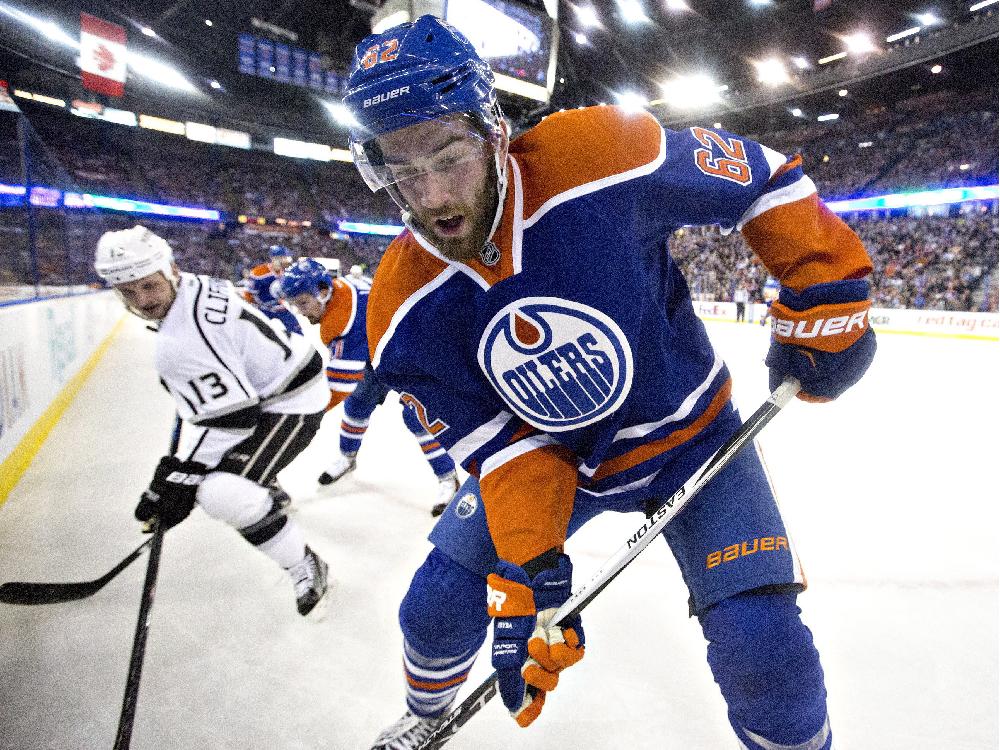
[416,378,800,750]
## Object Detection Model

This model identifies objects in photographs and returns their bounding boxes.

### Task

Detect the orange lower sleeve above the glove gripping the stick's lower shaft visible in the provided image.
[479,445,577,565]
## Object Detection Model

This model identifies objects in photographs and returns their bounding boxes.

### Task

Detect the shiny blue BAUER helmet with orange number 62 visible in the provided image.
[344,15,502,197]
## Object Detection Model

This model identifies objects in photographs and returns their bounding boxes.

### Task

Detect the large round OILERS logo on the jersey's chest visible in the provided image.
[479,297,634,432]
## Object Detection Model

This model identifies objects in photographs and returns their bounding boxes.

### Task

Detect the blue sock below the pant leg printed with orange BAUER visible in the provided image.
[699,592,833,750]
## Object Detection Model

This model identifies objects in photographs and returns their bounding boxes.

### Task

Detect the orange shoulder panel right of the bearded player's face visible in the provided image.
[510,107,663,222]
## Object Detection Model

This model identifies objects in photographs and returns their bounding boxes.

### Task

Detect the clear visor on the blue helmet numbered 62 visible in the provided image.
[351,115,491,192]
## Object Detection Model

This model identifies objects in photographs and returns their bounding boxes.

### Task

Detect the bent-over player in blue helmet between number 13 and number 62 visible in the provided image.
[279,258,458,516]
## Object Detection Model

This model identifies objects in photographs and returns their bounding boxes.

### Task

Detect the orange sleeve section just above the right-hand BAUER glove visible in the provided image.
[742,193,872,292]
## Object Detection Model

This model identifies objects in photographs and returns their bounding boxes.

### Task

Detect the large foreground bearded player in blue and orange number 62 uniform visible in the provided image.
[345,16,875,750]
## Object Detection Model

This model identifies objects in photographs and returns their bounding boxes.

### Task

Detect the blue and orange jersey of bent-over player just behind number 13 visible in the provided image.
[319,278,371,409]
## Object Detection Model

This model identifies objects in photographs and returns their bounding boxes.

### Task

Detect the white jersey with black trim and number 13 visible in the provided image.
[155,273,329,468]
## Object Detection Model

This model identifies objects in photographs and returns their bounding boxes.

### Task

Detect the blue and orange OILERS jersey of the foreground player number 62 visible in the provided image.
[368,107,871,564]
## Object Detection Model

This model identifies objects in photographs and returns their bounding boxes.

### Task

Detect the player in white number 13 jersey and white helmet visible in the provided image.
[94,226,327,615]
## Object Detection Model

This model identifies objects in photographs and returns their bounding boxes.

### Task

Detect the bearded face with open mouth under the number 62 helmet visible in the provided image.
[379,118,497,261]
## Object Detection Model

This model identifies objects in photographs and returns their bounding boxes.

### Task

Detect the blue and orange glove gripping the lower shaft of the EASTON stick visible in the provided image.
[487,554,584,727]
